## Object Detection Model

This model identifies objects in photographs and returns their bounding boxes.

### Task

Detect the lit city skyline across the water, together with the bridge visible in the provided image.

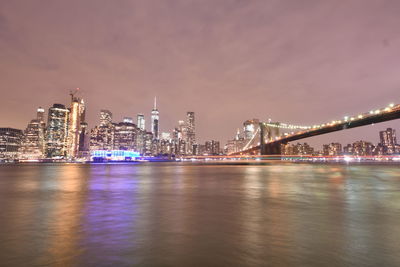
[0,88,400,160]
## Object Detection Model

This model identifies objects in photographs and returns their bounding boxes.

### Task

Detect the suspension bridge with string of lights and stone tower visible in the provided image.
[230,104,400,156]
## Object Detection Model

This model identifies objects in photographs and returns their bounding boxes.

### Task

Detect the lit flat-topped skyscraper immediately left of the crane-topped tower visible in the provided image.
[46,104,69,158]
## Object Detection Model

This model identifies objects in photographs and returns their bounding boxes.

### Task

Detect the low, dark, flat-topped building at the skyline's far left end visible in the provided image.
[0,128,23,160]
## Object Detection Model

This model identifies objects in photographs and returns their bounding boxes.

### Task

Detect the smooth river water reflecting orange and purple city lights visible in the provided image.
[0,162,400,266]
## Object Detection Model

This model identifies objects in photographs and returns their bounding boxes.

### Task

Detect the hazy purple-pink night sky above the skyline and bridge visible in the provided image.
[0,0,400,148]
